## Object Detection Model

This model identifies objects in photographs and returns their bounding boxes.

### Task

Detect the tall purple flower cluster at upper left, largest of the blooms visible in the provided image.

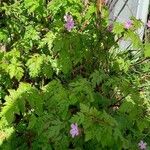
[64,14,74,32]
